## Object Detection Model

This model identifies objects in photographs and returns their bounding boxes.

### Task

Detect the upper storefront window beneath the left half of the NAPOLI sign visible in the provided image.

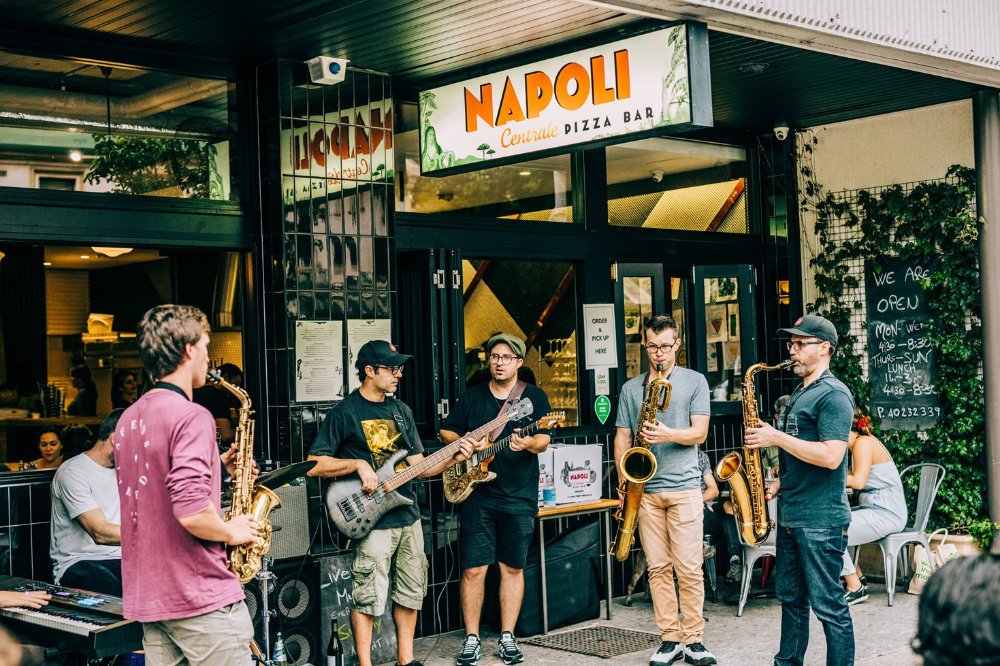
[395,111,573,223]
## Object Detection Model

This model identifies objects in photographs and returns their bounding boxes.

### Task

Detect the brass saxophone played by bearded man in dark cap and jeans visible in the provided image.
[715,359,795,546]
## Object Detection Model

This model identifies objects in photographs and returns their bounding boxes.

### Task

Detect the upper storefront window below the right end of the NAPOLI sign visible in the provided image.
[607,138,750,234]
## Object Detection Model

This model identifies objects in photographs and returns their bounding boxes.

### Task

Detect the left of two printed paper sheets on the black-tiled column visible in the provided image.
[295,321,344,402]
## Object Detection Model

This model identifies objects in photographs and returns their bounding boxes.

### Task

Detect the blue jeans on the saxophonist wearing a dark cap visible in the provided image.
[774,525,854,666]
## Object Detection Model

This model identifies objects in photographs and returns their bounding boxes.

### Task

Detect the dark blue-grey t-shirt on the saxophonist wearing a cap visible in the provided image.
[778,370,854,528]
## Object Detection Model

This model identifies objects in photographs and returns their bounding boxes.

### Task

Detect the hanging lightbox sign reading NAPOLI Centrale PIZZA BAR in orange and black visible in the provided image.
[419,23,712,175]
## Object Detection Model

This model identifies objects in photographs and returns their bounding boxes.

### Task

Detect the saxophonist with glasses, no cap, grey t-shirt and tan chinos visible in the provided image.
[615,315,716,666]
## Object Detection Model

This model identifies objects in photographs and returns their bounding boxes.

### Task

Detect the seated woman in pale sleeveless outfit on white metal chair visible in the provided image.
[841,409,906,605]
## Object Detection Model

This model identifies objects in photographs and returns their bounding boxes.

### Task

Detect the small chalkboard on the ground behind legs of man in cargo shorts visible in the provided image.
[317,553,396,665]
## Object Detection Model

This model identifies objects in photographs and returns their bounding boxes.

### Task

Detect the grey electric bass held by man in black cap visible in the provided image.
[326,398,534,539]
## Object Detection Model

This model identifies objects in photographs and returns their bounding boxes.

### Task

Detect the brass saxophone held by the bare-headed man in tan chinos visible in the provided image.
[609,364,670,562]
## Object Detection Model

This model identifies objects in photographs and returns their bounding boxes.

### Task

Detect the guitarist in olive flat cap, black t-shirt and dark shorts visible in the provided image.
[441,333,549,666]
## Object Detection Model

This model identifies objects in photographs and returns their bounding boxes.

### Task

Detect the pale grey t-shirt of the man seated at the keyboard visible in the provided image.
[49,453,122,583]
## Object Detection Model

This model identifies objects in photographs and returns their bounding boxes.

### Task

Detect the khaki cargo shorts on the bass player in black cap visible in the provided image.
[351,520,427,617]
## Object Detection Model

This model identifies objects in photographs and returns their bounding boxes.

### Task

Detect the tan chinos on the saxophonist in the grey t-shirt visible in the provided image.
[639,489,705,645]
